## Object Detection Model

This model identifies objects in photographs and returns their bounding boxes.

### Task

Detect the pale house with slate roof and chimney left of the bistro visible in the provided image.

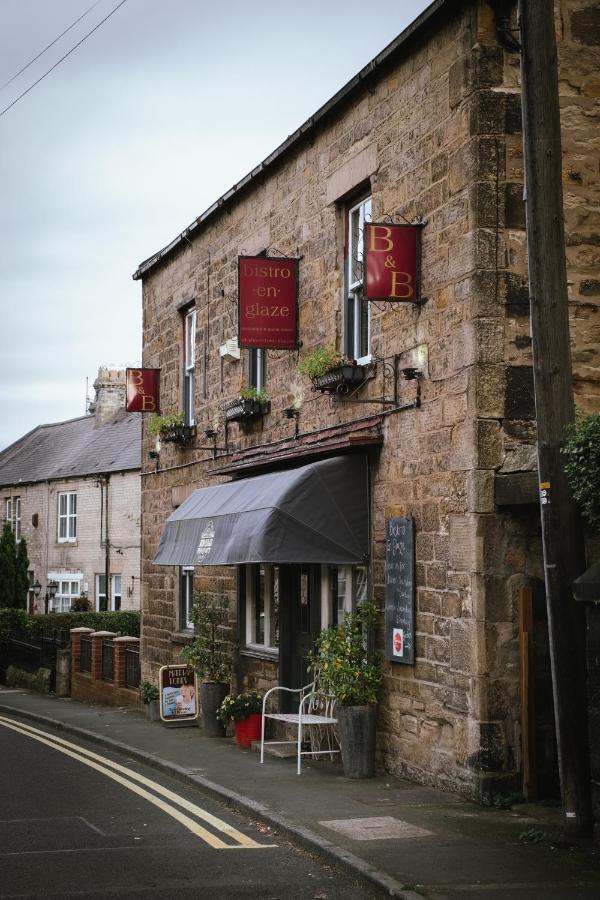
[0,368,141,613]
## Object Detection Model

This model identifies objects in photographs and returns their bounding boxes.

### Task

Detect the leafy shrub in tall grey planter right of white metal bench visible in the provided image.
[310,601,382,778]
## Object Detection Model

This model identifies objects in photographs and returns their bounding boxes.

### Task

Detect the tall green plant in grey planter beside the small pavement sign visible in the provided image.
[181,593,233,737]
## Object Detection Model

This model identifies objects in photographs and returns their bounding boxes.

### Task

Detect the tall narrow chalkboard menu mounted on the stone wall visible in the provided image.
[385,517,415,665]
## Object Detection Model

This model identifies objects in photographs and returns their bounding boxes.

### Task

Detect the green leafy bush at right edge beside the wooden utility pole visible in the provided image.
[562,413,600,531]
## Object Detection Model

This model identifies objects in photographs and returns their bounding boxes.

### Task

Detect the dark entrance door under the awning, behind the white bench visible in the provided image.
[279,565,321,712]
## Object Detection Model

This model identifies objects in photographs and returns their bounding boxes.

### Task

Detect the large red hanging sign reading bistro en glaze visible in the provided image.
[238,256,298,350]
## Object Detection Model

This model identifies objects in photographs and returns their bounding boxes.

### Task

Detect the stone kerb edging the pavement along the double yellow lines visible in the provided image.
[0,702,426,900]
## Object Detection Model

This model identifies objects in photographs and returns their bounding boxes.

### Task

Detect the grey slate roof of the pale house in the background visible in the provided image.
[0,410,142,486]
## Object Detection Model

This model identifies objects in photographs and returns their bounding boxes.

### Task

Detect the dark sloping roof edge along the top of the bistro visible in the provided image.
[133,0,455,281]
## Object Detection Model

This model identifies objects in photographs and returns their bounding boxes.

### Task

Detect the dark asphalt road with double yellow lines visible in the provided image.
[0,717,378,900]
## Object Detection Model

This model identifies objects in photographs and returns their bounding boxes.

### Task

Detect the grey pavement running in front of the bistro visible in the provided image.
[0,687,600,900]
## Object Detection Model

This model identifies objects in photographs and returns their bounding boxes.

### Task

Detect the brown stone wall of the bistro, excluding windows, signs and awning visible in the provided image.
[137,0,599,794]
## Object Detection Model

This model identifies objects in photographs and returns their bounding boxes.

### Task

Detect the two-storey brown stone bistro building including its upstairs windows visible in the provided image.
[134,0,600,795]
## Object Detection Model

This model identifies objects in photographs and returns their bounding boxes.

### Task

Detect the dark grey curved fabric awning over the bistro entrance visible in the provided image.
[154,455,369,566]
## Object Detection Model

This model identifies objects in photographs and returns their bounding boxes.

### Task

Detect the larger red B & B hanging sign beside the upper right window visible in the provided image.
[364,222,421,303]
